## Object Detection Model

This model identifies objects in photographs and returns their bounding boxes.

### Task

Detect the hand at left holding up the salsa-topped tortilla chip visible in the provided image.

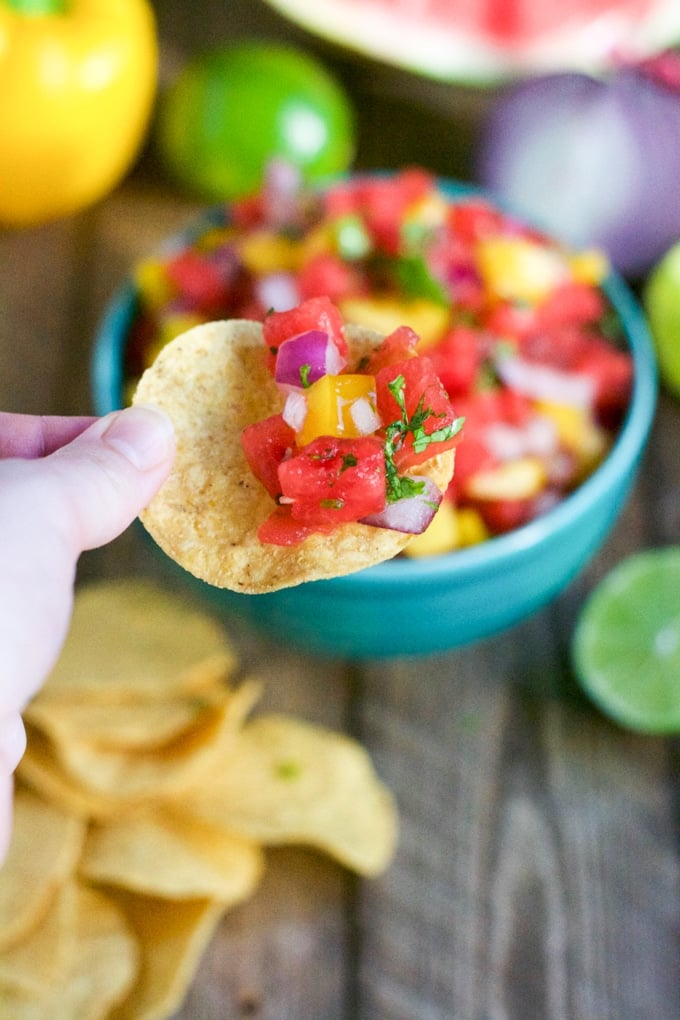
[0,407,174,863]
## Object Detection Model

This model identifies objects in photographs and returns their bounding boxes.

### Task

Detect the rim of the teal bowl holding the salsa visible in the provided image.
[91,171,659,589]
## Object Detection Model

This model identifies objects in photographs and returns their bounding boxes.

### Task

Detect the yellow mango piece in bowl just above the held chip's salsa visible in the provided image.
[338,297,451,351]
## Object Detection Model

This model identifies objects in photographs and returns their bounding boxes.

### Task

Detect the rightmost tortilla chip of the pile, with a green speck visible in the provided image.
[170,715,397,875]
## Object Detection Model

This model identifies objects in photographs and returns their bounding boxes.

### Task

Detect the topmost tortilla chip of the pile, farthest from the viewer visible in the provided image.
[34,578,236,705]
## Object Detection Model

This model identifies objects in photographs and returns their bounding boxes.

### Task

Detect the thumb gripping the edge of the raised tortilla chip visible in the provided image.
[42,405,174,553]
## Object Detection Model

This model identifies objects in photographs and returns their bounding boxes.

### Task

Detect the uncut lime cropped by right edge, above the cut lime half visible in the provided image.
[642,242,680,396]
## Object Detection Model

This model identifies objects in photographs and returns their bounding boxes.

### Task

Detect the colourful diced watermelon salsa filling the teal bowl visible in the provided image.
[126,166,632,556]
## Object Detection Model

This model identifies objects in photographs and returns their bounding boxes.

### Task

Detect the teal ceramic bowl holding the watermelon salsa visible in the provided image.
[92,184,657,659]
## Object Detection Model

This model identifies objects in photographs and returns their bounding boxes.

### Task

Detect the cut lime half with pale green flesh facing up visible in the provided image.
[572,546,680,733]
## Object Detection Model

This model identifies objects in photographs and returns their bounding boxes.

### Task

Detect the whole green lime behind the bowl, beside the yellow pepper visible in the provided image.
[157,42,355,202]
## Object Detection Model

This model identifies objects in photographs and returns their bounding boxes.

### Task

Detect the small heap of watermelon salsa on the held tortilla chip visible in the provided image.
[242,297,463,546]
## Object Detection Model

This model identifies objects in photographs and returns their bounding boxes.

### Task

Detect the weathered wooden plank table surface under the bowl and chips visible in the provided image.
[0,0,680,1020]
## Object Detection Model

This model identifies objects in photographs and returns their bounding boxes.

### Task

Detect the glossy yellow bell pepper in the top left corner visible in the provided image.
[0,0,158,226]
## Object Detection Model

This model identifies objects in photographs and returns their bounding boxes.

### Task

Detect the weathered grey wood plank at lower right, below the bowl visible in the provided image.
[359,613,680,1020]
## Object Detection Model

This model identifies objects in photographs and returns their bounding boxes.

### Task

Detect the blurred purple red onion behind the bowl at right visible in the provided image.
[477,67,680,278]
